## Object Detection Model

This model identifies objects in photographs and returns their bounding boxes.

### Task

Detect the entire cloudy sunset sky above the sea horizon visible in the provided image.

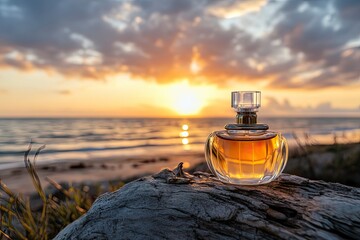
[0,0,360,117]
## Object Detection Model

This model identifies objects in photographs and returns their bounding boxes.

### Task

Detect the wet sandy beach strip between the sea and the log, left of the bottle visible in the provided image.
[0,152,205,194]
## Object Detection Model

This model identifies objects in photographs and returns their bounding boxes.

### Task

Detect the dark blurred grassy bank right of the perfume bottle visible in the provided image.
[285,134,360,187]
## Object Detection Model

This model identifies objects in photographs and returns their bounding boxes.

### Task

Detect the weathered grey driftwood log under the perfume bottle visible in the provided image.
[55,163,360,239]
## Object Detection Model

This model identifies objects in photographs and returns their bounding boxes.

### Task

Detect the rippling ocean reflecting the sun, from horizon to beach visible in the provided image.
[0,117,360,169]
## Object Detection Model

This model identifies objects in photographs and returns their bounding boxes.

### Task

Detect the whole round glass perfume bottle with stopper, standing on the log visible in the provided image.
[205,91,288,185]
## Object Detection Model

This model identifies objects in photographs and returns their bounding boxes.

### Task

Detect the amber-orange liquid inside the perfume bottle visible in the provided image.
[210,134,280,180]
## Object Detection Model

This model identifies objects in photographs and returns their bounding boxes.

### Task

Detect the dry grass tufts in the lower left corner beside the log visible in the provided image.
[0,144,123,240]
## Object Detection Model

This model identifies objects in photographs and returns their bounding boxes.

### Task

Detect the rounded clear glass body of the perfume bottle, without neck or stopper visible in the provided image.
[205,130,288,185]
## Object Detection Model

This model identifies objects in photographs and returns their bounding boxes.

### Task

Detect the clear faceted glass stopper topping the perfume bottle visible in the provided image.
[231,91,261,112]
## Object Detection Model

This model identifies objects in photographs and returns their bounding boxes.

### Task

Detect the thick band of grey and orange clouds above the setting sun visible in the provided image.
[0,0,360,88]
